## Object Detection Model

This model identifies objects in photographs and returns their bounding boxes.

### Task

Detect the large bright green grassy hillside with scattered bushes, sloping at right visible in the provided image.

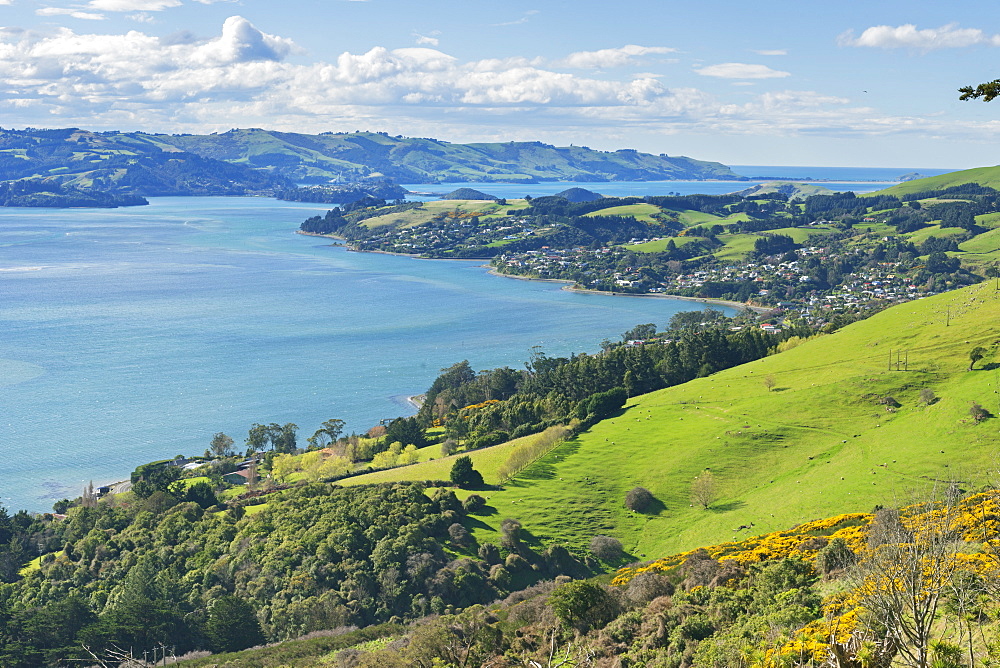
[352,282,1000,559]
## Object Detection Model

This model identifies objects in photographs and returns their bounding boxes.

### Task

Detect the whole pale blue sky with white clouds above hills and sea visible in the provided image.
[0,0,1000,169]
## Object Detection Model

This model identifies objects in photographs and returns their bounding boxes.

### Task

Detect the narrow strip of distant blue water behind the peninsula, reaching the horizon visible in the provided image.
[401,165,955,200]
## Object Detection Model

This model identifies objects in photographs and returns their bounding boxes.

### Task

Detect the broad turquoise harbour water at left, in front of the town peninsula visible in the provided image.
[0,198,736,511]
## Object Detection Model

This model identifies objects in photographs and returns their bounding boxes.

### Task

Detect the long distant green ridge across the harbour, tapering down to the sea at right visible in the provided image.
[131,128,743,183]
